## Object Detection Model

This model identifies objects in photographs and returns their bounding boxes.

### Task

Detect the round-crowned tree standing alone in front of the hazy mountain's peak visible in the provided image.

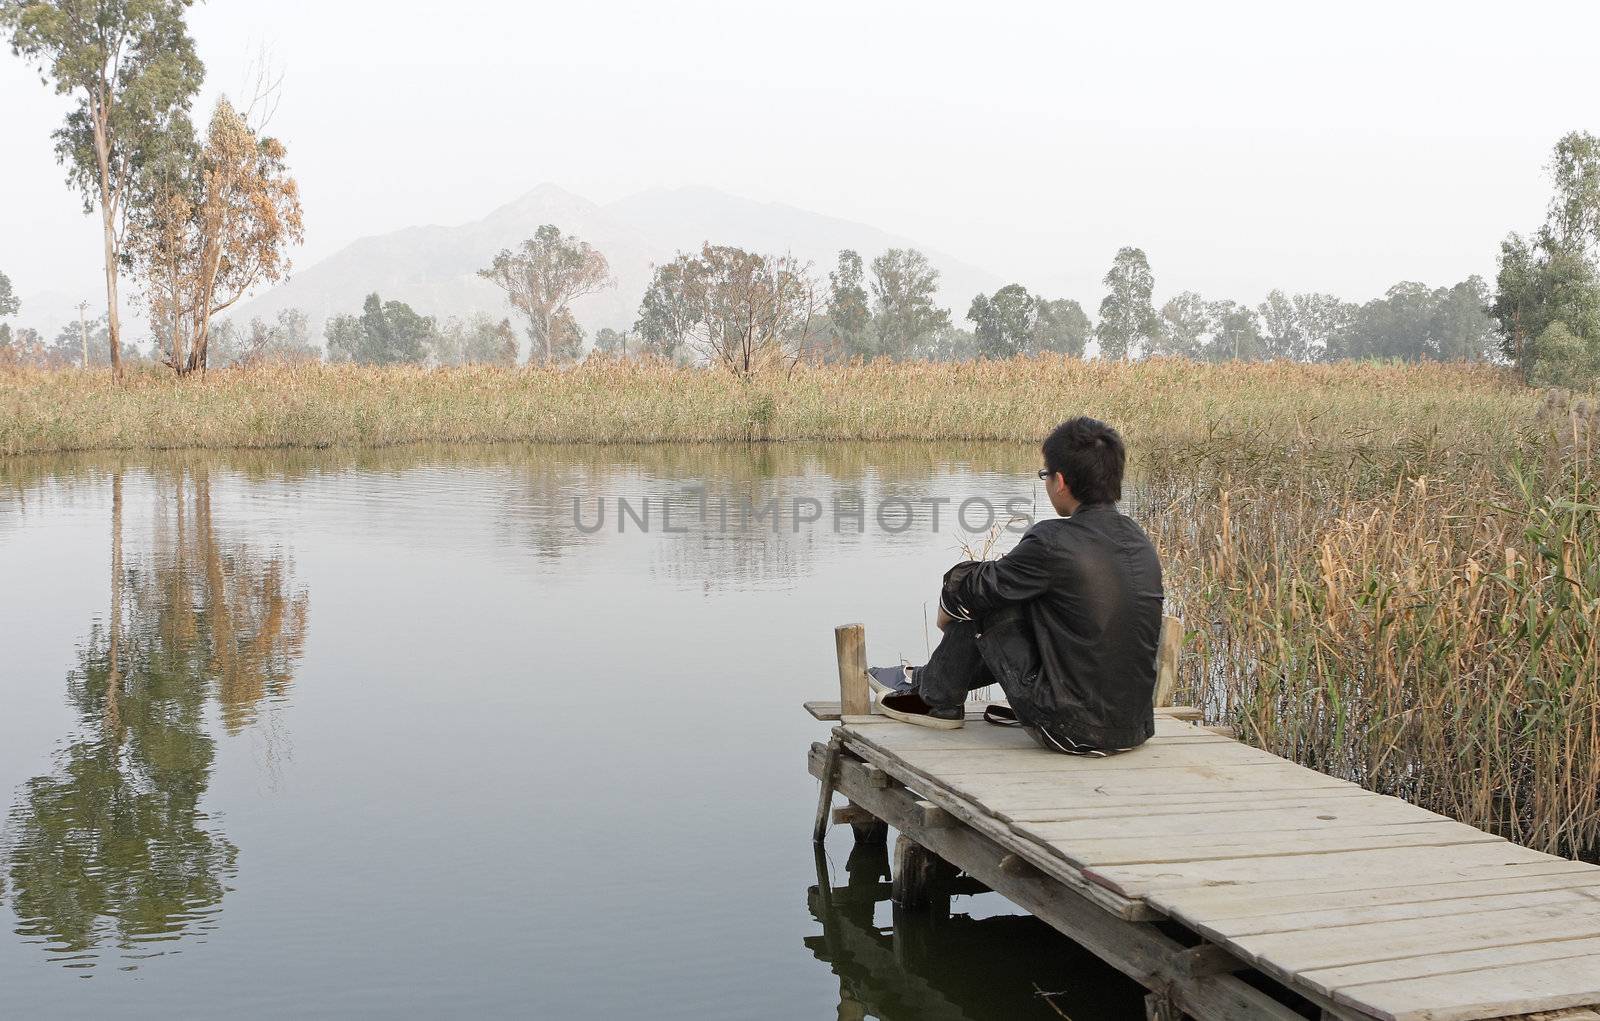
[478,224,616,365]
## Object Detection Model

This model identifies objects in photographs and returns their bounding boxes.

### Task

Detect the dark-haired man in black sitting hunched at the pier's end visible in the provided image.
[869,418,1162,755]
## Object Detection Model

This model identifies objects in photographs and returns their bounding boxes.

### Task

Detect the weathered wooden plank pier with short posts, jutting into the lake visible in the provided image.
[806,626,1600,1021]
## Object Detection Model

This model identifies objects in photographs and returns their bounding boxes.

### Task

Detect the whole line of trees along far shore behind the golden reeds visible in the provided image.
[0,0,1580,386]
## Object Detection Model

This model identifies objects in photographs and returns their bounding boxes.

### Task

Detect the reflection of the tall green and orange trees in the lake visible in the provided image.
[3,469,307,975]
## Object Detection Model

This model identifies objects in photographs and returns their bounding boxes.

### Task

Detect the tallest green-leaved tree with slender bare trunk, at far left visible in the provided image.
[0,0,203,379]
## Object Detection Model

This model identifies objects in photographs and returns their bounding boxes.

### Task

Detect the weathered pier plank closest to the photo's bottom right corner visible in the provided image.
[1334,954,1600,1021]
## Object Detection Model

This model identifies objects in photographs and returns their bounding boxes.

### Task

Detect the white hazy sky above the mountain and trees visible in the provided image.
[0,0,1600,322]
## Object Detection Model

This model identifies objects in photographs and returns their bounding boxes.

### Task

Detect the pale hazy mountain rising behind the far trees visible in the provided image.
[234,184,1005,345]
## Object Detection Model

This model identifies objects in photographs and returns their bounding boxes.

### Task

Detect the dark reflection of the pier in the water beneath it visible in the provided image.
[805,843,1144,1021]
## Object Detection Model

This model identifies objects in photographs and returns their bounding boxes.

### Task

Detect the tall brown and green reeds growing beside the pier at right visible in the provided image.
[1147,396,1600,859]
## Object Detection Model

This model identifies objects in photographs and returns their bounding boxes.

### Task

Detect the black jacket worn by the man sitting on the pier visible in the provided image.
[941,504,1162,749]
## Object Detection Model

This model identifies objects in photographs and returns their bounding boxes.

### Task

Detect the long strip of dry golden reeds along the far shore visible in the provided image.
[0,358,1534,454]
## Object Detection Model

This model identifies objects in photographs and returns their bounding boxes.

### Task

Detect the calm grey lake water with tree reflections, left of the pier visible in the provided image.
[0,445,1142,1021]
